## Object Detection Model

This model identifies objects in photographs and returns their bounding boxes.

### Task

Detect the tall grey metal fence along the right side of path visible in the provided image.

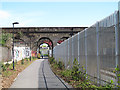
[53,11,120,84]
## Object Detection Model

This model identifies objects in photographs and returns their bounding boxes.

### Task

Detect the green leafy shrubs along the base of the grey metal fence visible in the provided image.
[49,57,115,90]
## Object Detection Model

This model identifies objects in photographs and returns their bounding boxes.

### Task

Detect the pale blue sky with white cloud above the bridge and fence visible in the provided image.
[0,2,118,27]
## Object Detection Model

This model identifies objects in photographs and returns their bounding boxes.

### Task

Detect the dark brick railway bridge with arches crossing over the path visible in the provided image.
[2,27,87,55]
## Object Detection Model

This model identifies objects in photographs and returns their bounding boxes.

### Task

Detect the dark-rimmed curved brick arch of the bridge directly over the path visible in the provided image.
[37,37,54,56]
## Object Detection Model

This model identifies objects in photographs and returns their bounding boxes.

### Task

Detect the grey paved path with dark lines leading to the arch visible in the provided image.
[11,59,71,88]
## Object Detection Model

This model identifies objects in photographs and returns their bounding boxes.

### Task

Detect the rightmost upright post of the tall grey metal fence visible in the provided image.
[115,11,120,85]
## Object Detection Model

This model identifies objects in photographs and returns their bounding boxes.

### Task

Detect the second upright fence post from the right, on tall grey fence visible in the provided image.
[96,22,100,84]
